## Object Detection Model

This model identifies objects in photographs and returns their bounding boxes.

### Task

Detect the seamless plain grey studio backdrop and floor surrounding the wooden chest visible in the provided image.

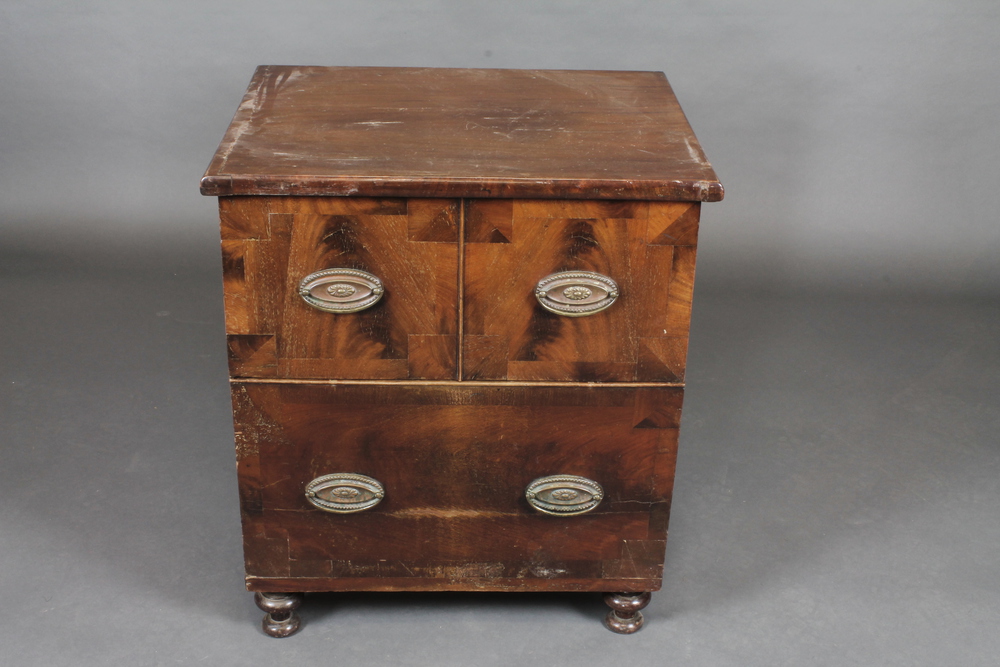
[0,0,1000,666]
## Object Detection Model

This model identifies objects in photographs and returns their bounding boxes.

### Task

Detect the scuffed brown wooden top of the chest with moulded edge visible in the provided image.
[201,65,723,201]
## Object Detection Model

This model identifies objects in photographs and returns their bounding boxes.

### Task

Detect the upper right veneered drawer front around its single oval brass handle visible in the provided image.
[462,199,700,382]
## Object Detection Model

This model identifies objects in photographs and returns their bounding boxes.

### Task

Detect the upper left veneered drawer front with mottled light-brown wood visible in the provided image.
[219,197,459,380]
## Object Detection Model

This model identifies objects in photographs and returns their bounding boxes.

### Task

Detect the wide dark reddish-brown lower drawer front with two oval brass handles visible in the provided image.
[233,383,683,591]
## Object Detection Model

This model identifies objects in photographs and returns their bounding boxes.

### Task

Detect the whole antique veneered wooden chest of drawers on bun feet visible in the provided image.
[202,67,722,636]
